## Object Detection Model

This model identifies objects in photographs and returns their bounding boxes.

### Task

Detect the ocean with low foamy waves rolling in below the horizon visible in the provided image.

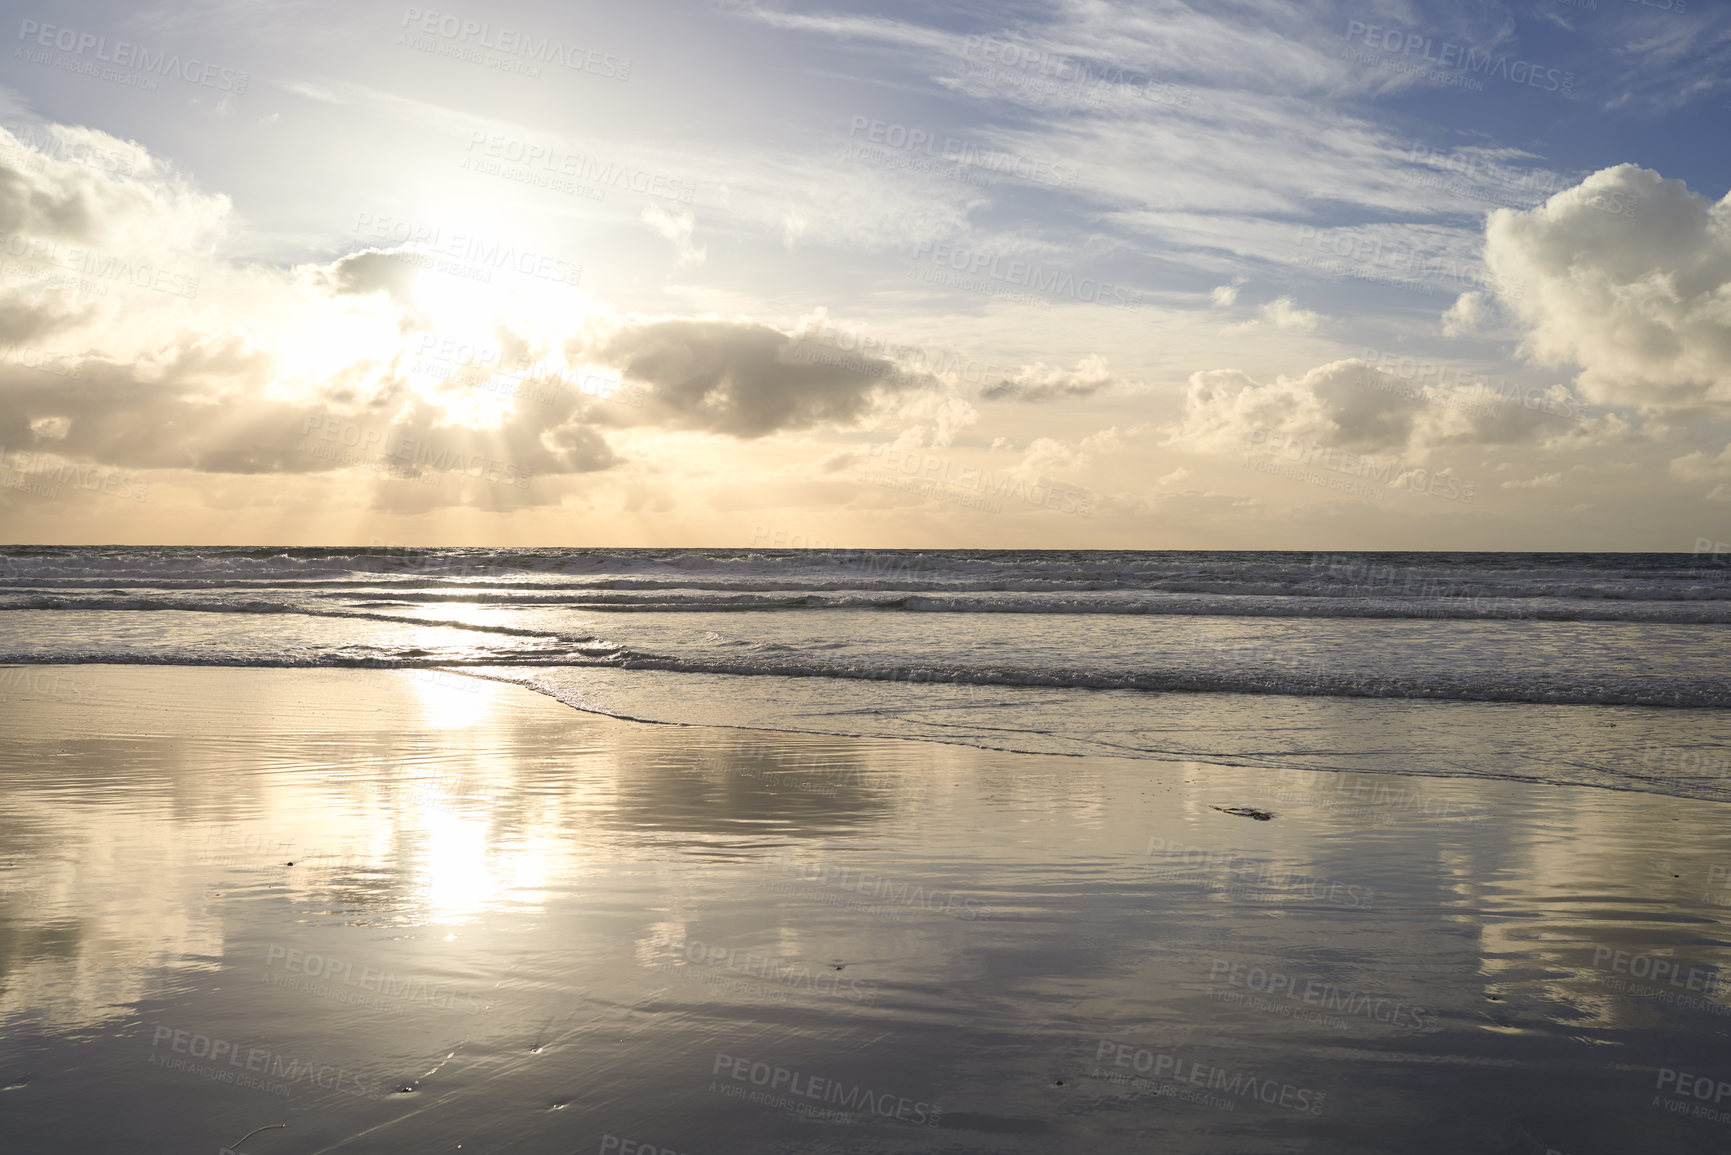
[13,547,1731,800]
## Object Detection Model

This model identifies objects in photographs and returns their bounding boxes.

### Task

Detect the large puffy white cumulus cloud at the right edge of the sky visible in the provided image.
[1485,165,1731,410]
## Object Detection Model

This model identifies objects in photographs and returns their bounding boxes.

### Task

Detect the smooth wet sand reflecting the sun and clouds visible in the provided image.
[0,667,1731,1155]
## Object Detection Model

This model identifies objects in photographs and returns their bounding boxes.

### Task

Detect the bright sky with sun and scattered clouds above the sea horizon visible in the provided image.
[0,0,1731,552]
